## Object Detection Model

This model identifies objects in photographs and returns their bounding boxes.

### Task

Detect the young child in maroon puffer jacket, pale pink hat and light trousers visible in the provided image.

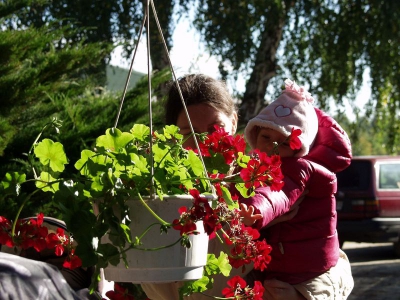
[242,80,354,299]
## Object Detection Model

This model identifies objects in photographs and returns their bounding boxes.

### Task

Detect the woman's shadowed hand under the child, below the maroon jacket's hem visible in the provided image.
[263,279,306,300]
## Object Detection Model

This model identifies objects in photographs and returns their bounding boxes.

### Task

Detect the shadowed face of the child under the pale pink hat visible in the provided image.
[256,128,296,157]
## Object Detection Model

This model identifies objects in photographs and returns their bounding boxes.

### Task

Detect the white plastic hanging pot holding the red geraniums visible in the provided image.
[102,195,208,283]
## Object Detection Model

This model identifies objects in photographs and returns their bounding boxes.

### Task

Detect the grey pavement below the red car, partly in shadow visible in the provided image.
[343,242,400,300]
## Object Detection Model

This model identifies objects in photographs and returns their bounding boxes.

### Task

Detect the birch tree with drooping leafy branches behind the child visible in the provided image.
[185,0,400,152]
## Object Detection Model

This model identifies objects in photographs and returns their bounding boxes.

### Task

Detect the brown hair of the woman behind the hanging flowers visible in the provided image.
[165,74,237,125]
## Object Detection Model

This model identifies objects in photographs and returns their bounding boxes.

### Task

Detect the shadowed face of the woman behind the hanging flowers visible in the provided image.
[176,103,237,149]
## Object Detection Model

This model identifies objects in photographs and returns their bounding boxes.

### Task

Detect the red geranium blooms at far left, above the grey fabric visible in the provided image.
[0,213,82,269]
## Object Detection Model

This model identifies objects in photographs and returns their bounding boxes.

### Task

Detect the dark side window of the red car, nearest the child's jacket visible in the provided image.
[337,160,371,191]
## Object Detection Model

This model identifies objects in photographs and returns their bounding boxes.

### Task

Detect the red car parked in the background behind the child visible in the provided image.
[336,156,400,247]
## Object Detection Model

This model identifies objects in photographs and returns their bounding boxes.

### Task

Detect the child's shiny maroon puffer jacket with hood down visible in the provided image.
[242,109,352,284]
